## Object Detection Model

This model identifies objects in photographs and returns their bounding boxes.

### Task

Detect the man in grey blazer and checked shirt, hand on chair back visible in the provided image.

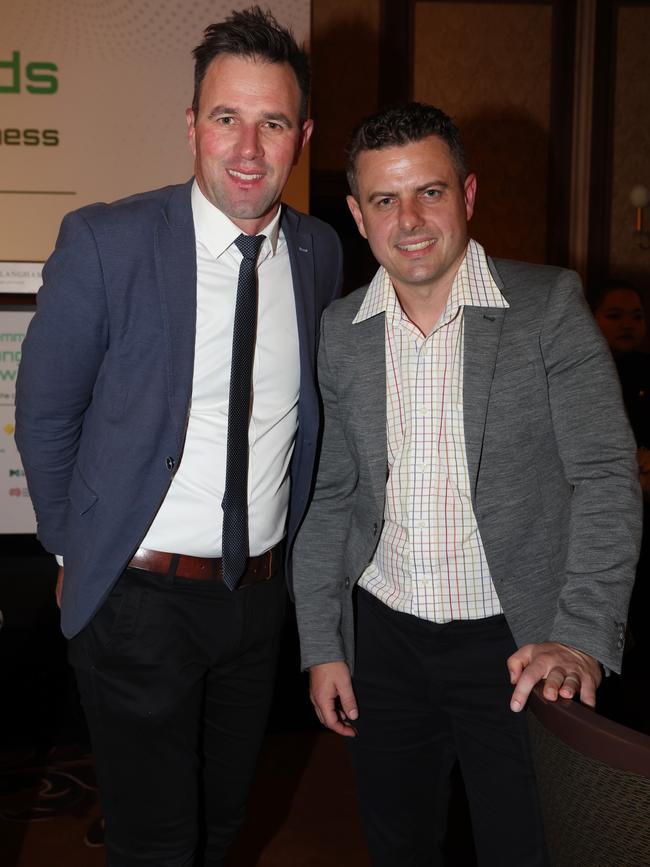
[294,103,640,867]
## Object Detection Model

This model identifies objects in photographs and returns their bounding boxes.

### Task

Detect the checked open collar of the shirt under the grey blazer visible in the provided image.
[353,238,510,324]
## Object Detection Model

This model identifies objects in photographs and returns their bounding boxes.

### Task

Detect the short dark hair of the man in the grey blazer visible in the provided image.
[346,102,468,196]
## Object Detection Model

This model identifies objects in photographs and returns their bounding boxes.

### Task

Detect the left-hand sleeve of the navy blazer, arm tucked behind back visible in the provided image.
[15,212,108,553]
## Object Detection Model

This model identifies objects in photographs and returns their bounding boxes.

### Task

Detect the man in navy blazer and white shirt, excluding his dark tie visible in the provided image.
[16,7,341,867]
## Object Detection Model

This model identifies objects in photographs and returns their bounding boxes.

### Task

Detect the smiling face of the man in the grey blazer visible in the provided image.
[348,136,476,294]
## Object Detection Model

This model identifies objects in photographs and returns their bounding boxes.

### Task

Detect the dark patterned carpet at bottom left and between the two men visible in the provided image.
[0,732,369,867]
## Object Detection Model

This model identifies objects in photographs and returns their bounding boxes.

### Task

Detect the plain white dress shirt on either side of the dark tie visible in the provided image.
[141,181,300,557]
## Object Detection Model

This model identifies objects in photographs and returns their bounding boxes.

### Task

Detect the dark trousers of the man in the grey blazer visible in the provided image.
[348,590,547,867]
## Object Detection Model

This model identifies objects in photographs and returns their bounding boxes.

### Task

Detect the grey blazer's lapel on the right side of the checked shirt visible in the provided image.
[463,307,506,496]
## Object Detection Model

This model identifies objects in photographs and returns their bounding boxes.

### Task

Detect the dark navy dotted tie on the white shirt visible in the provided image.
[221,235,264,590]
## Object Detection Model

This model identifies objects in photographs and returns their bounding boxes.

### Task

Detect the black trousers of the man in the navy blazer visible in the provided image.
[69,569,286,867]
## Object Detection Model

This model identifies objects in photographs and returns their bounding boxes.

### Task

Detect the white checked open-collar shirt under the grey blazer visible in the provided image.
[355,241,508,623]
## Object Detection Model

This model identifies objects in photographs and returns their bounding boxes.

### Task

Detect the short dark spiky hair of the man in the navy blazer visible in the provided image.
[192,6,311,126]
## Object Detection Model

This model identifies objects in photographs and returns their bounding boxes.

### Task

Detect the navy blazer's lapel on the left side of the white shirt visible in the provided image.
[155,180,196,450]
